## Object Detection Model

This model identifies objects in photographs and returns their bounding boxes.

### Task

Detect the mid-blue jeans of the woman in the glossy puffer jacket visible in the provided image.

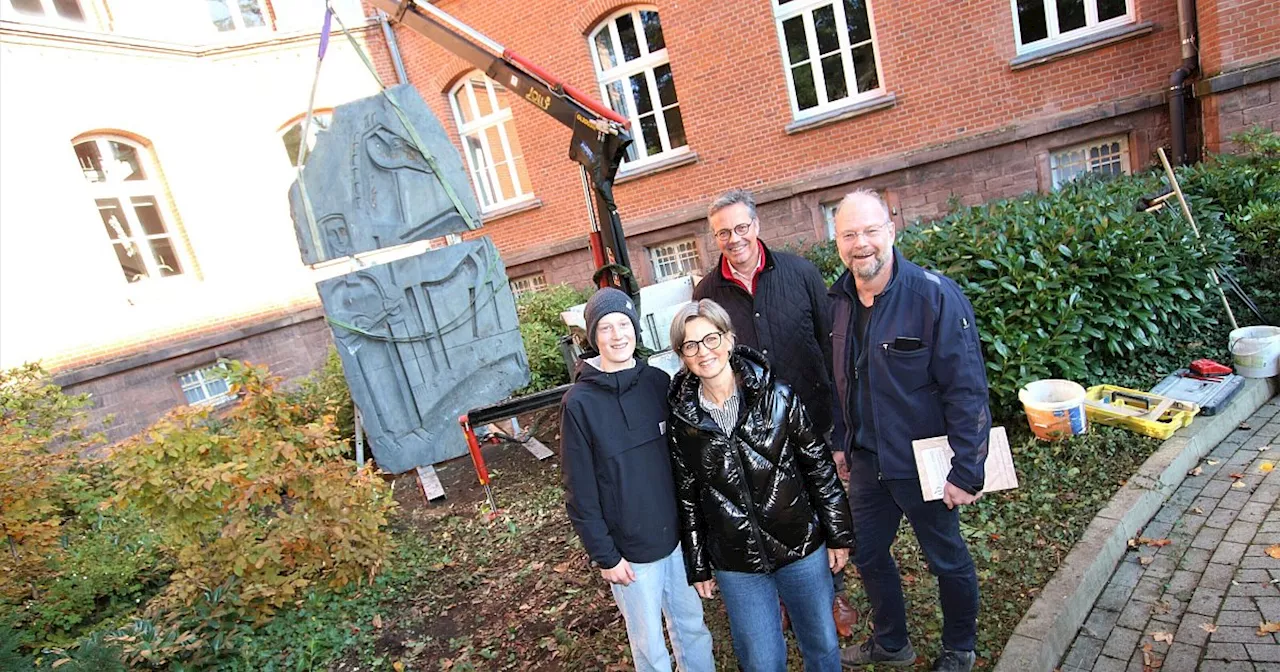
[716,545,840,672]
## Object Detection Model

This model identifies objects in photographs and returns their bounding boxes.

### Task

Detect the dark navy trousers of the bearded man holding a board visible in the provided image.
[847,449,978,652]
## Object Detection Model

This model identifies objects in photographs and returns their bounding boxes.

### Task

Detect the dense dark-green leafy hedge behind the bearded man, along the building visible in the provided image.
[805,128,1280,417]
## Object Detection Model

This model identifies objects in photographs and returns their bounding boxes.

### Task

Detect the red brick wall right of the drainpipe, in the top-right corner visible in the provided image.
[1196,0,1280,76]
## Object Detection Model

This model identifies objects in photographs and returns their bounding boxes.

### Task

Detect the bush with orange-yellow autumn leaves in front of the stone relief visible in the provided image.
[113,362,394,620]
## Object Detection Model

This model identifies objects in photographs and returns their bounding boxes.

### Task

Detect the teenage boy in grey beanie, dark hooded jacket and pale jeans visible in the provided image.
[561,288,714,672]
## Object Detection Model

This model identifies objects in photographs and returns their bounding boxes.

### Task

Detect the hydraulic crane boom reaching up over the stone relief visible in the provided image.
[371,0,643,338]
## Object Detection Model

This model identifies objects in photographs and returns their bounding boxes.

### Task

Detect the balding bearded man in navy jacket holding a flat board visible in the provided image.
[831,191,991,672]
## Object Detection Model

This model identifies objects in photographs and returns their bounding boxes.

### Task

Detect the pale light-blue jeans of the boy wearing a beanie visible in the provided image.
[613,544,716,672]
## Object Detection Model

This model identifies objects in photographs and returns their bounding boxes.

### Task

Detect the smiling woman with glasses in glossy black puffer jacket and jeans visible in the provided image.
[668,298,854,672]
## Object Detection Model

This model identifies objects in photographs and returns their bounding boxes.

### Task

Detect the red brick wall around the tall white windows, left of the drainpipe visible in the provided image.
[366,0,1179,262]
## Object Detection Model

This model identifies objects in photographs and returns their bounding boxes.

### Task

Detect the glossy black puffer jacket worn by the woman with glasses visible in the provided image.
[667,346,854,584]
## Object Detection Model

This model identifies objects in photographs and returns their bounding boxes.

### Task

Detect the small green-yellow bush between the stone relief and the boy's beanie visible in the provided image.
[516,284,591,394]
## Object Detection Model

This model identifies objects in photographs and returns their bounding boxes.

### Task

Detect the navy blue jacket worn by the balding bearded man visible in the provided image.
[829,248,991,494]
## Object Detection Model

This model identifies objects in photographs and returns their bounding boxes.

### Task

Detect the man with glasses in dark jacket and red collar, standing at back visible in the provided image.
[694,189,856,637]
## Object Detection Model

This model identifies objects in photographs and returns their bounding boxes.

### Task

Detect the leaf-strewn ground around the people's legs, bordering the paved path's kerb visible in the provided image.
[309,416,1158,671]
